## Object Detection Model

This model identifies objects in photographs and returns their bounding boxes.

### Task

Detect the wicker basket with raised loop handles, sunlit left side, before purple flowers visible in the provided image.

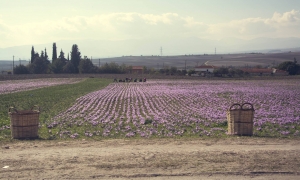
[227,103,254,136]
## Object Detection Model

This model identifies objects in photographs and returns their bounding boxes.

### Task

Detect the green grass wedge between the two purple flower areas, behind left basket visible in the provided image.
[0,78,112,141]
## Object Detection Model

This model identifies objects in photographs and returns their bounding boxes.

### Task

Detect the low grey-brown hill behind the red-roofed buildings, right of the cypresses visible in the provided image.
[93,51,300,69]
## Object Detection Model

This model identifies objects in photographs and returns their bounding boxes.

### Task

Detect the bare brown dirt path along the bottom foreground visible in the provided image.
[0,137,300,180]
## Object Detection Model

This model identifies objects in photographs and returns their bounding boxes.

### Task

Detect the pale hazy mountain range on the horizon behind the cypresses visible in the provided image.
[0,37,300,60]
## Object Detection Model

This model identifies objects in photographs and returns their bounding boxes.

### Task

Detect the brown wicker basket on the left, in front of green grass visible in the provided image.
[8,106,40,139]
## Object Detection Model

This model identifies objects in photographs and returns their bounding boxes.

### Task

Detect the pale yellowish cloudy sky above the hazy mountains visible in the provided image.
[0,0,300,48]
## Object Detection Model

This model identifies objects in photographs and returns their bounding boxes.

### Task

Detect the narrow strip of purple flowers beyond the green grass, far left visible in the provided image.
[0,78,82,94]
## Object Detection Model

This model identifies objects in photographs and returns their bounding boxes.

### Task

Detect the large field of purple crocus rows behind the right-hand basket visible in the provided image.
[47,79,300,138]
